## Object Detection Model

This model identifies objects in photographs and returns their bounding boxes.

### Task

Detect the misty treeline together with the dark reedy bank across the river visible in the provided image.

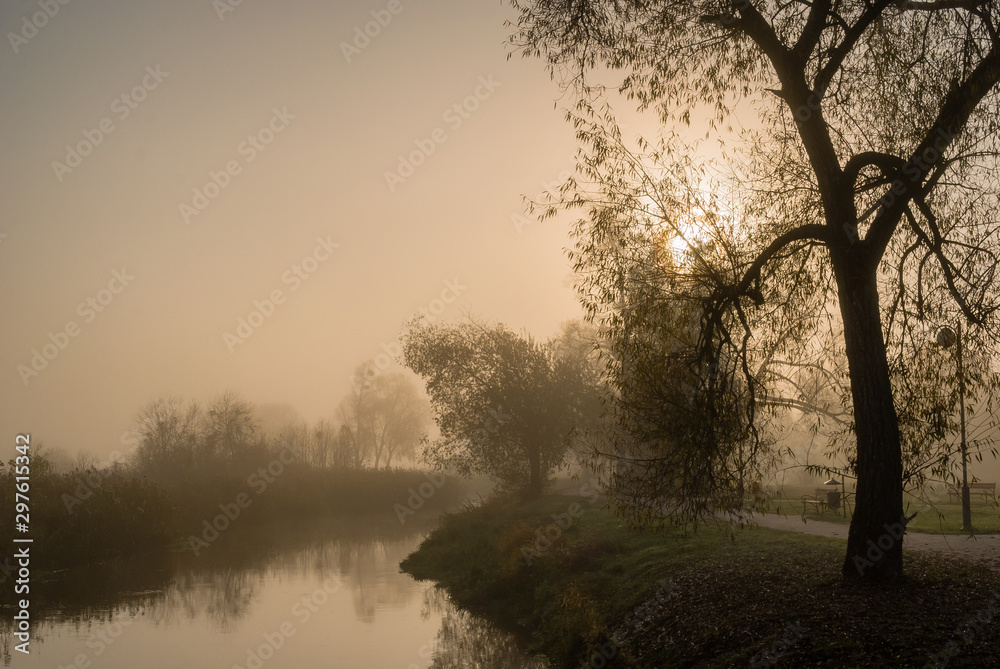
[0,393,462,581]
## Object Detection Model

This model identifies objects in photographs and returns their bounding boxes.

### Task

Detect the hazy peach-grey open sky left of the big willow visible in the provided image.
[0,0,580,455]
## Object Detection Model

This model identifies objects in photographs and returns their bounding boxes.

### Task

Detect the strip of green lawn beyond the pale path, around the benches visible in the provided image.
[771,486,1000,534]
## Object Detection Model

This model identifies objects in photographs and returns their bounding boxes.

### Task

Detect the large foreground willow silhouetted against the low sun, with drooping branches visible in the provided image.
[512,0,1000,581]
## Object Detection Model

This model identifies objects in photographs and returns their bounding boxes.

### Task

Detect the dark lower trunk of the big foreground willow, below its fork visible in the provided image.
[834,254,905,583]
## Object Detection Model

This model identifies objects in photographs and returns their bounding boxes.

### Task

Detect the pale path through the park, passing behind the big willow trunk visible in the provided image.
[755,514,1000,571]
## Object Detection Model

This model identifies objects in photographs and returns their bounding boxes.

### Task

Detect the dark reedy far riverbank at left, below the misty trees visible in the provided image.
[0,464,466,576]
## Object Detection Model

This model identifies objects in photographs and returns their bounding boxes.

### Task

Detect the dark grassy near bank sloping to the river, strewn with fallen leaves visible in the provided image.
[402,496,1000,668]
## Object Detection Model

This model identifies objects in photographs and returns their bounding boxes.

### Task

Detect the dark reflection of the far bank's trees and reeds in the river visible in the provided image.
[11,517,432,648]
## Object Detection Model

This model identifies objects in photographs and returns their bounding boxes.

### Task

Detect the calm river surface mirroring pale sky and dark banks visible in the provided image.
[0,520,545,669]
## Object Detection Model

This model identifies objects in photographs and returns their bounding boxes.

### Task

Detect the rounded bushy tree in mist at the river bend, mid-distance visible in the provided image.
[402,322,589,497]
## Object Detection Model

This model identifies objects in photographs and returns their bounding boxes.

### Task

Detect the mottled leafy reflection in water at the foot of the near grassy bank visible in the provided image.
[431,607,548,669]
